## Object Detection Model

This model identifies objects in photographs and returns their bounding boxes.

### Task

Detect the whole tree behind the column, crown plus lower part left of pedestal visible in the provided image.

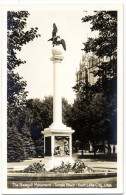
[24,96,71,156]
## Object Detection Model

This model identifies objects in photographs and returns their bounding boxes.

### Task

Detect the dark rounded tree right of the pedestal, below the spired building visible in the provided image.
[69,90,112,155]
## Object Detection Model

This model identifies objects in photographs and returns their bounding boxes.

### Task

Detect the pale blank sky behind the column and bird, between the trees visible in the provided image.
[16,6,95,103]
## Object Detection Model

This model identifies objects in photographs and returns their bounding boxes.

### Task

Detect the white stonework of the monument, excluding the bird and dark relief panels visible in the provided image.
[43,46,74,169]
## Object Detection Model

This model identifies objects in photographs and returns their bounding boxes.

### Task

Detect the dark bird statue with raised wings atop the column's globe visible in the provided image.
[48,23,66,51]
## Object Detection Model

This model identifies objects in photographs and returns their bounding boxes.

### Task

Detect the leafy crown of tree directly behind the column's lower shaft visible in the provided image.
[26,96,71,130]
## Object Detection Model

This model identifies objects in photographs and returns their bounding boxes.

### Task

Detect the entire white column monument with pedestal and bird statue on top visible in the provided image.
[43,23,74,170]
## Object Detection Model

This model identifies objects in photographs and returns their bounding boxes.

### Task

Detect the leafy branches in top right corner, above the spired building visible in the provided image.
[82,11,117,57]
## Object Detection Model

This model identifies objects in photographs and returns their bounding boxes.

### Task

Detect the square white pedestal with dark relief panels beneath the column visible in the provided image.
[43,124,74,170]
